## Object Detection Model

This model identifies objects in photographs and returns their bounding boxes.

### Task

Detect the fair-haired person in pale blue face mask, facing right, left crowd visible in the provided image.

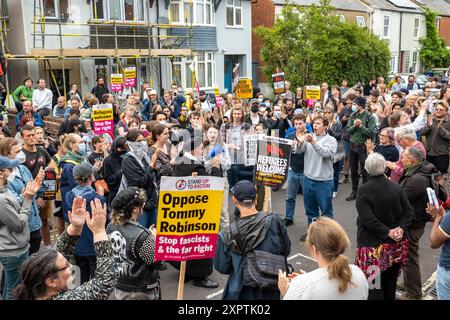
[59,133,87,222]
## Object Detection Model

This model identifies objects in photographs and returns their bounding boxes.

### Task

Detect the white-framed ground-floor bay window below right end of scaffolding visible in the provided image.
[172,51,216,89]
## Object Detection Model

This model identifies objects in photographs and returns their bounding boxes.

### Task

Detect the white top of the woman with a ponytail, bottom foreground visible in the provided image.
[284,264,369,300]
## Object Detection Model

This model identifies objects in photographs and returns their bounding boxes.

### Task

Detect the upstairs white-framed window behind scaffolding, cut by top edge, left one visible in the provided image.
[91,0,145,21]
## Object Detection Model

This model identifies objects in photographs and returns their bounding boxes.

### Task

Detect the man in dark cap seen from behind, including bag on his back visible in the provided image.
[214,180,291,300]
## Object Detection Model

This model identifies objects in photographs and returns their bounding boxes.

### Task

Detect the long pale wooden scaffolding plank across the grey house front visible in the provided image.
[30,49,192,58]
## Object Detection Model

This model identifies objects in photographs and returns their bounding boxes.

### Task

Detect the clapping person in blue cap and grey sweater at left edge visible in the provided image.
[0,156,41,300]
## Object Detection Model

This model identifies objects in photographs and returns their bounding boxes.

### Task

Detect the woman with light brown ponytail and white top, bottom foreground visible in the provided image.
[278,217,369,300]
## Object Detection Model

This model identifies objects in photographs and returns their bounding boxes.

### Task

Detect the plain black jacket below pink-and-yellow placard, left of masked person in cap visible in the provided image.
[103,139,126,204]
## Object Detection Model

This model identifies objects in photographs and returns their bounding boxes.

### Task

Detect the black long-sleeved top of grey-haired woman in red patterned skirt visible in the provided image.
[356,175,414,248]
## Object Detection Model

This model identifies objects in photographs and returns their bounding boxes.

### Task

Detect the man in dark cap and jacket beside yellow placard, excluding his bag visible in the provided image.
[214,180,291,300]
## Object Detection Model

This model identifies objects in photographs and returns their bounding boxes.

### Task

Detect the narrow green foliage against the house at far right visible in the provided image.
[419,7,450,69]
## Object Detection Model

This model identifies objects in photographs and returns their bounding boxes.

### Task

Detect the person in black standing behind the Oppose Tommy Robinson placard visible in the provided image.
[170,130,221,289]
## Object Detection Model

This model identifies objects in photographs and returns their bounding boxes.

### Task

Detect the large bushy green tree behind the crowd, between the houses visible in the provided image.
[255,0,390,86]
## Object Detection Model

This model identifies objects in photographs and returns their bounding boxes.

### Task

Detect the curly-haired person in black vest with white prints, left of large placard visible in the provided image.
[107,187,161,300]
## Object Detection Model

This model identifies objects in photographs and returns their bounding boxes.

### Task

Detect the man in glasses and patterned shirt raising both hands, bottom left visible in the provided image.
[14,197,119,300]
